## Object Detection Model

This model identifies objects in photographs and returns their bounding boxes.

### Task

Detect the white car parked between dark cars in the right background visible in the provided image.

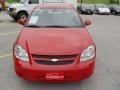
[94,4,110,15]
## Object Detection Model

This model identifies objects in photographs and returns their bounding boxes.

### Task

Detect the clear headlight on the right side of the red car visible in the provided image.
[80,45,95,62]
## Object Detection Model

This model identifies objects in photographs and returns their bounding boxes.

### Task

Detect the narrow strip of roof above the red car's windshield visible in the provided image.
[36,4,74,9]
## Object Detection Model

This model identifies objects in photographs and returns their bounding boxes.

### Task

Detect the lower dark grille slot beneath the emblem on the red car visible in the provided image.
[35,60,74,65]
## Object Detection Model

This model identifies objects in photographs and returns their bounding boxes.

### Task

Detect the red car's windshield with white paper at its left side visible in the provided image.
[26,8,83,27]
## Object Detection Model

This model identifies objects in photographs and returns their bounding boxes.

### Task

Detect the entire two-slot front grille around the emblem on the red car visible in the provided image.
[32,54,77,65]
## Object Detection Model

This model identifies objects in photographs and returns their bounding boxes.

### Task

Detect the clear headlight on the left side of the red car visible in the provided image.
[14,45,29,61]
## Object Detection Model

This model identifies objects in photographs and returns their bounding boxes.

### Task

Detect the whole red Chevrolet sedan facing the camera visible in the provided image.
[13,4,96,82]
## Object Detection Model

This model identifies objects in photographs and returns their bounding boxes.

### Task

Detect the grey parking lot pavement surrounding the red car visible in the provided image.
[0,12,120,90]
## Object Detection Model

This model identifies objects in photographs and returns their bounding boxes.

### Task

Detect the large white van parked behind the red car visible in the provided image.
[8,0,77,20]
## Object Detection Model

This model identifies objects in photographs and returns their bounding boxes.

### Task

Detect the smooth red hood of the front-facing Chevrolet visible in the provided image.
[17,28,93,55]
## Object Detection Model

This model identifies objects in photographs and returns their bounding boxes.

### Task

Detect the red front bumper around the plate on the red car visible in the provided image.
[14,58,95,82]
